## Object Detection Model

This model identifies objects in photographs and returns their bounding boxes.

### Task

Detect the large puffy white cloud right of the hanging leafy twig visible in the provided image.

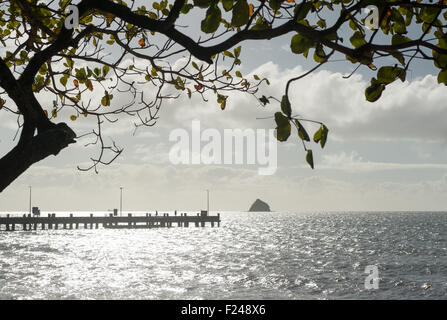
[288,71,447,141]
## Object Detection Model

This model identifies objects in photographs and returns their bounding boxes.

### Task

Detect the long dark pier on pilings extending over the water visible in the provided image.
[0,212,220,231]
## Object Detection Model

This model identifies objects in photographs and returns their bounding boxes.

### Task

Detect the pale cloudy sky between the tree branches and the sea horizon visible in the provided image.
[0,3,447,211]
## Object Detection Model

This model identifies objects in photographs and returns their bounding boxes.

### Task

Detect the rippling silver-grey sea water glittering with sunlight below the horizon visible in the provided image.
[0,212,447,299]
